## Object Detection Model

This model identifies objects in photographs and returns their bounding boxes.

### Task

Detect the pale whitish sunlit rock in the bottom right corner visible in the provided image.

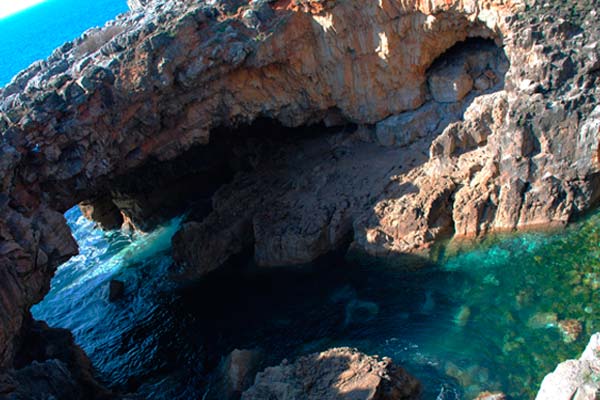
[536,333,600,400]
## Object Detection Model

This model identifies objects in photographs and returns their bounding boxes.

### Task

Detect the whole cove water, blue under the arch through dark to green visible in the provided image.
[33,210,600,399]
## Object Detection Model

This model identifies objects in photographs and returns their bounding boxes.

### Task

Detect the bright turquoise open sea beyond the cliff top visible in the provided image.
[0,0,127,86]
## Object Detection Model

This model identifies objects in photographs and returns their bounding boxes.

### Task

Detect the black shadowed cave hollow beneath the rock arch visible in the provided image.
[79,117,356,236]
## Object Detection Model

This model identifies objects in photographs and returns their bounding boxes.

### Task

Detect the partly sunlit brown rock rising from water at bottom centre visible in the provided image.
[242,347,421,400]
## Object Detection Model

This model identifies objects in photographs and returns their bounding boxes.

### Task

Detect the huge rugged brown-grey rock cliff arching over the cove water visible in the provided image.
[0,0,600,396]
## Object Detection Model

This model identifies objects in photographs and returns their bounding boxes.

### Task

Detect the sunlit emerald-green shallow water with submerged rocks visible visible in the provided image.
[396,213,600,399]
